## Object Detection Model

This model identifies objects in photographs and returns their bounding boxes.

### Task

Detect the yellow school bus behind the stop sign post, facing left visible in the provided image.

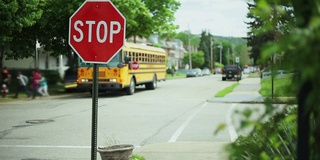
[77,42,167,95]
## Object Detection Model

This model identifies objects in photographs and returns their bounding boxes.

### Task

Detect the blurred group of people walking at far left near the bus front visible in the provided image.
[1,67,50,99]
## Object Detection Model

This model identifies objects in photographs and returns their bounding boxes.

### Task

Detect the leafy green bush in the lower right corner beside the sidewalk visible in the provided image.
[226,107,297,159]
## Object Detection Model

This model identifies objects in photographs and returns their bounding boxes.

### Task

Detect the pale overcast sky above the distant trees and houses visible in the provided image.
[175,0,248,37]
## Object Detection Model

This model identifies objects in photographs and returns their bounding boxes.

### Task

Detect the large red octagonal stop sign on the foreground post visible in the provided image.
[69,0,126,63]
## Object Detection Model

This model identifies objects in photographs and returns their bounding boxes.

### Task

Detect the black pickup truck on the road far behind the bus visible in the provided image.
[221,65,242,81]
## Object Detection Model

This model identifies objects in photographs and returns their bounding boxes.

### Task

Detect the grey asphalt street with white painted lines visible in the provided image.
[0,75,263,160]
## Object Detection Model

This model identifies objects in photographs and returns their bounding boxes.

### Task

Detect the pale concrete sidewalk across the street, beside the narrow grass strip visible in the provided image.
[211,77,264,103]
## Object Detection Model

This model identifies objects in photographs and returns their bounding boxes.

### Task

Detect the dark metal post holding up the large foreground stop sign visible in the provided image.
[91,64,99,160]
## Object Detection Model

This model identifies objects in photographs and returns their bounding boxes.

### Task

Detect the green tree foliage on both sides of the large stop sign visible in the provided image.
[0,0,180,64]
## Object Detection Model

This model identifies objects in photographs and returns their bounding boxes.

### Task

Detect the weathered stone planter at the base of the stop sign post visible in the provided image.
[97,144,134,160]
